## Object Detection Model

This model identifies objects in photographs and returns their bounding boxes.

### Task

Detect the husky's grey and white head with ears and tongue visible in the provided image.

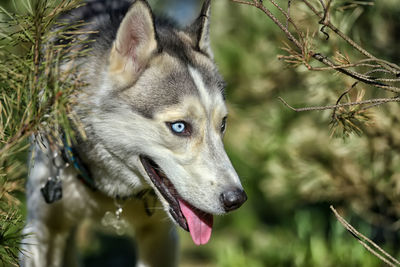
[87,0,247,244]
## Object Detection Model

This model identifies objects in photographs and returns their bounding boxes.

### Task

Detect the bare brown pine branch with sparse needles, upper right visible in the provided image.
[232,0,400,137]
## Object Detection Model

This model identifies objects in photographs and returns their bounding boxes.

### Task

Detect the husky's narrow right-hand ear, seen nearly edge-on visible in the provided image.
[186,0,213,58]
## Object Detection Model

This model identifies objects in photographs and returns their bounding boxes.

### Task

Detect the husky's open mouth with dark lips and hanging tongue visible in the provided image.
[140,156,213,245]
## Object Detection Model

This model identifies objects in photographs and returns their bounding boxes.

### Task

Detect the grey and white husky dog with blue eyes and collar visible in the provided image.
[21,0,247,267]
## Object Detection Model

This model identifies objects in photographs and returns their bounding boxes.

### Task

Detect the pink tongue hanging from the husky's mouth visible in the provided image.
[179,199,213,245]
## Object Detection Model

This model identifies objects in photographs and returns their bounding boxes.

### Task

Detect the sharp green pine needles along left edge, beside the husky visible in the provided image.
[0,0,85,264]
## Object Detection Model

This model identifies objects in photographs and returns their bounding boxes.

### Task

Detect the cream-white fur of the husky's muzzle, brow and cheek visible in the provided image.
[83,57,241,214]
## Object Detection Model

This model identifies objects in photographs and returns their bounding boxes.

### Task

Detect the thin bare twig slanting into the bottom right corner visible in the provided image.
[330,206,400,267]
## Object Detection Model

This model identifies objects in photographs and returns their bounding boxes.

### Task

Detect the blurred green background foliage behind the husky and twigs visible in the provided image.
[2,0,400,267]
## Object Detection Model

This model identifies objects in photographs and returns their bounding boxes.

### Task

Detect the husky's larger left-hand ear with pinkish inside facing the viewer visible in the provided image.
[109,0,157,86]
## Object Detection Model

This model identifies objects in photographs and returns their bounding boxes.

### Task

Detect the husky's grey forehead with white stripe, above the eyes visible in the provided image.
[124,49,224,118]
